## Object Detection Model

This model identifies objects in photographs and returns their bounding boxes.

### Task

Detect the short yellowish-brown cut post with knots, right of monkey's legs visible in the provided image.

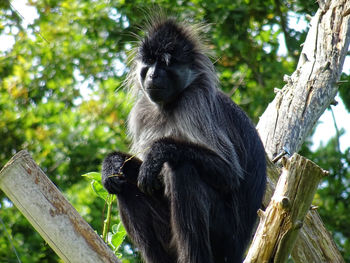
[244,154,328,263]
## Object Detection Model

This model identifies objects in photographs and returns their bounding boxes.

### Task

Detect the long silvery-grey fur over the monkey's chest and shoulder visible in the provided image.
[128,49,243,178]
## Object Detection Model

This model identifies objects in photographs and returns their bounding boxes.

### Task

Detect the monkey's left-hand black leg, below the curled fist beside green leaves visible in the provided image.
[117,185,176,263]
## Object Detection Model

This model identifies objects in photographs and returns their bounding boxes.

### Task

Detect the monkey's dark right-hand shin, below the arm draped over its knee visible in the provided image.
[164,162,213,263]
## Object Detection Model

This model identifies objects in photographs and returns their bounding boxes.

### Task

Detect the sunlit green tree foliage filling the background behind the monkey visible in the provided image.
[0,0,350,263]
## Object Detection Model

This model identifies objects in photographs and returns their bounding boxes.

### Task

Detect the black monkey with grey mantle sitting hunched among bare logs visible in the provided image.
[102,18,266,263]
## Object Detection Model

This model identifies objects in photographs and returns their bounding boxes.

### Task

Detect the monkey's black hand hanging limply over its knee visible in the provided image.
[137,141,167,195]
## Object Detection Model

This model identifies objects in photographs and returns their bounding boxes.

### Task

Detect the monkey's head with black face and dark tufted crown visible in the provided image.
[137,21,196,105]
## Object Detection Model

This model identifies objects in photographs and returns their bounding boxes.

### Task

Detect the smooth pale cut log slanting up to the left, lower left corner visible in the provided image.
[0,151,119,263]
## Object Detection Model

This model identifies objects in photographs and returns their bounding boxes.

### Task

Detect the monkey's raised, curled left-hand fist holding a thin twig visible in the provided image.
[102,152,142,194]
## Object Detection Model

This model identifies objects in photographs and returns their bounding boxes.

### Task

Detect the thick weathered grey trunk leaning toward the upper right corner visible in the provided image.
[257,0,350,159]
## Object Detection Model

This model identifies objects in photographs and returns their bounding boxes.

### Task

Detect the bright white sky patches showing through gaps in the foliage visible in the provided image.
[0,0,350,154]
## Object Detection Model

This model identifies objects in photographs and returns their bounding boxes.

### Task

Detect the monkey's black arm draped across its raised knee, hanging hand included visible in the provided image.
[138,138,239,194]
